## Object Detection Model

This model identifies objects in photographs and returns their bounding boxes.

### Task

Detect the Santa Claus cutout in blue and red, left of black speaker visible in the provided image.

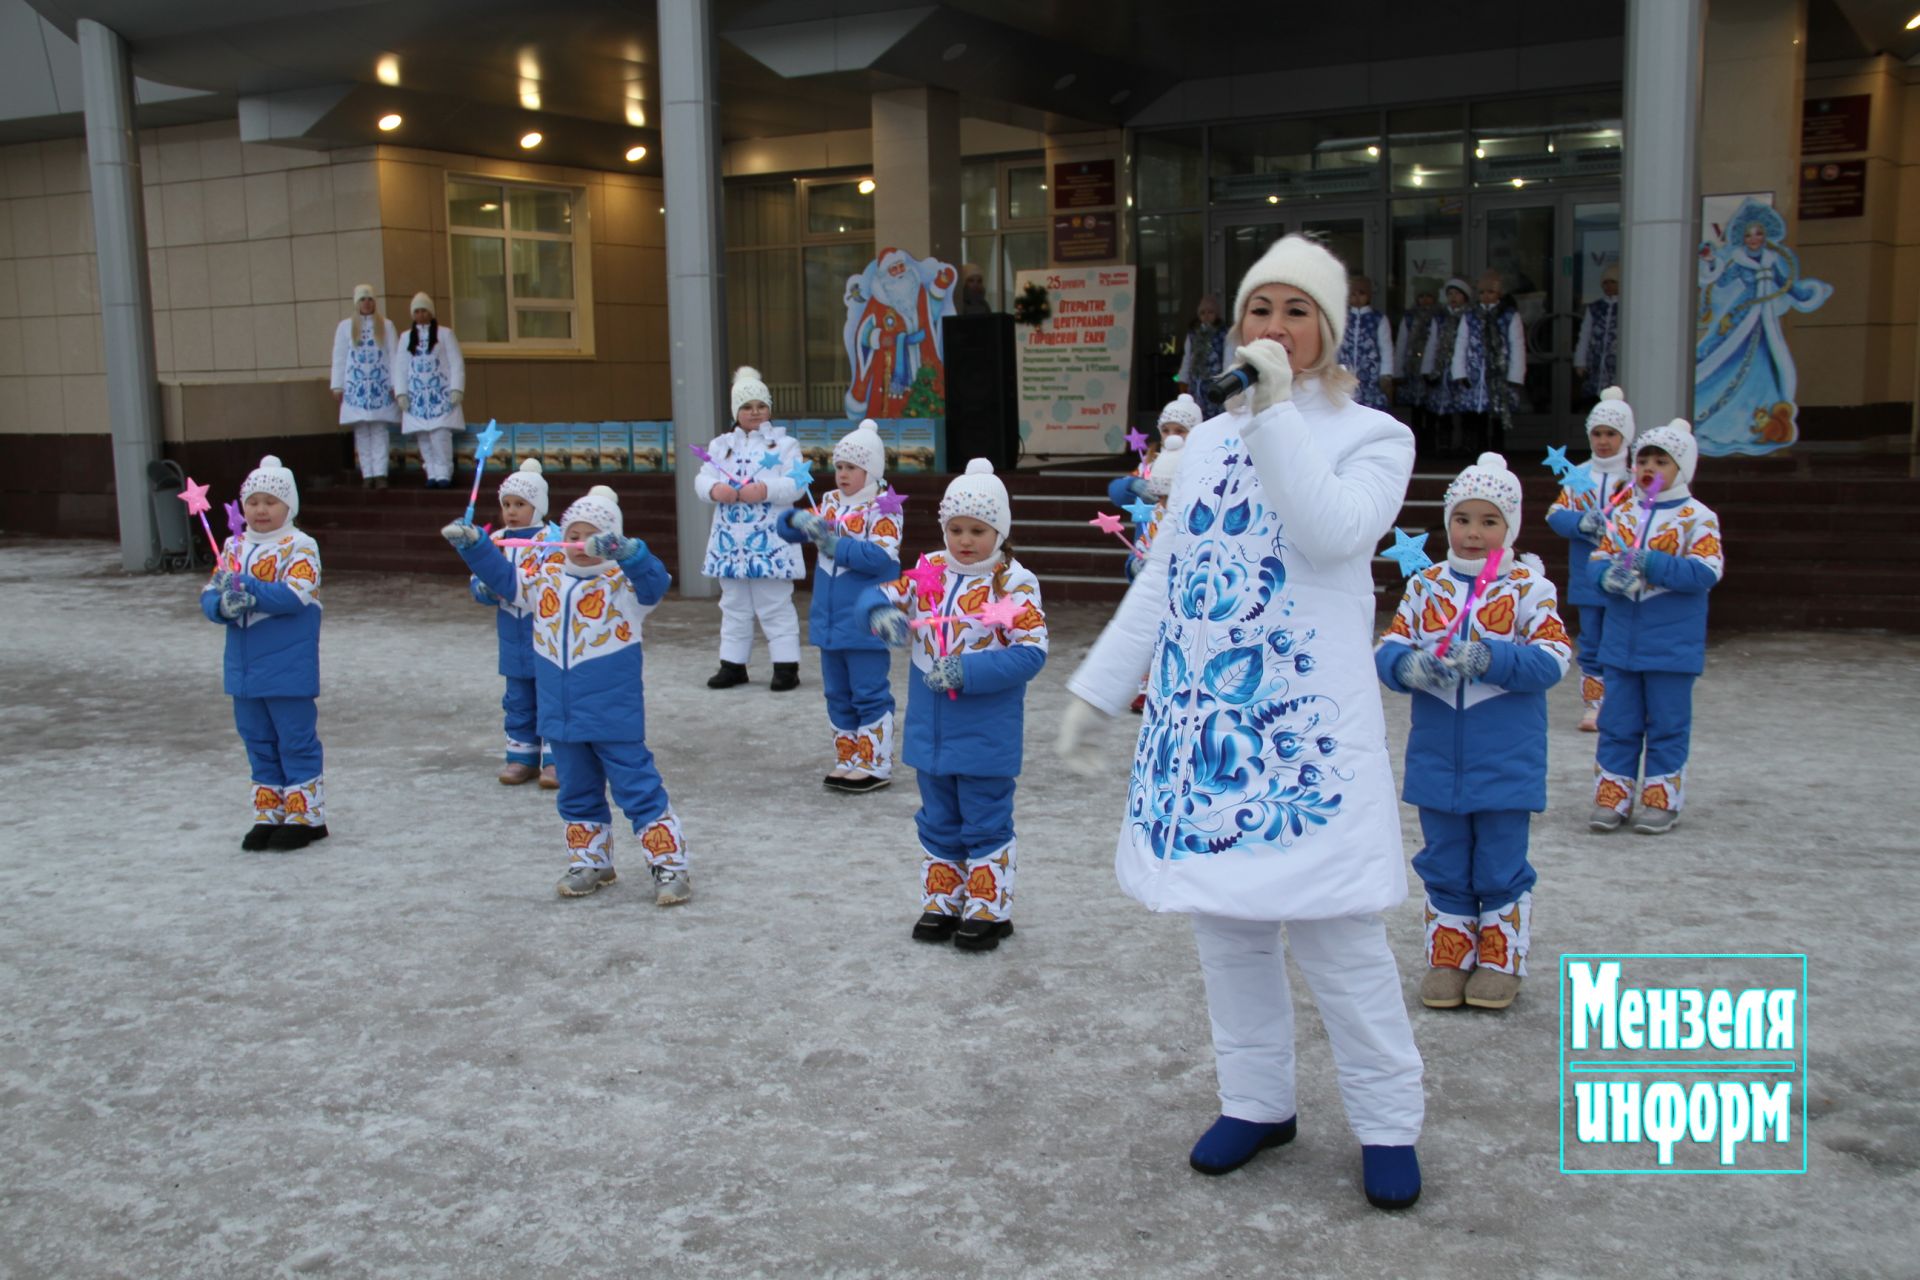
[845,248,960,420]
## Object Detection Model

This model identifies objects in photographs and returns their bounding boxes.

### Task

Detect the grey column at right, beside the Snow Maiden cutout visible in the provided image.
[1620,0,1707,428]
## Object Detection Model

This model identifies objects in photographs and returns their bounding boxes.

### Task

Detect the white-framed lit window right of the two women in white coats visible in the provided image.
[447,175,593,355]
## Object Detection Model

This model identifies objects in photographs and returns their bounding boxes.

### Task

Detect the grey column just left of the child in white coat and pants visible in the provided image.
[659,0,728,599]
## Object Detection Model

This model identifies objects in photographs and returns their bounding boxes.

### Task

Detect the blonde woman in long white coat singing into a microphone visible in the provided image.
[1060,236,1425,1209]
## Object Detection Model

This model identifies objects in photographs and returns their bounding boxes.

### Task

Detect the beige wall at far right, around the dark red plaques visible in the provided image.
[1782,58,1920,405]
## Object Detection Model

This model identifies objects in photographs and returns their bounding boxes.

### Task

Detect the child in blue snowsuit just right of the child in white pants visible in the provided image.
[778,418,902,791]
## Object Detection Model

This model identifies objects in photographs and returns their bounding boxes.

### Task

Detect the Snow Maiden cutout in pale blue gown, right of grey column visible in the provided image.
[1693,200,1834,457]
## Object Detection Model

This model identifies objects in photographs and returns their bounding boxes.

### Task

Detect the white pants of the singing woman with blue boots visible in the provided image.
[1194,913,1427,1146]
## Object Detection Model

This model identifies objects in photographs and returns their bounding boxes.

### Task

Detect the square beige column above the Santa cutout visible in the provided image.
[874,88,960,263]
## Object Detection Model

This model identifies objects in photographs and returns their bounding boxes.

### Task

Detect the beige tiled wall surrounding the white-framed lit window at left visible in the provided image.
[376,146,672,422]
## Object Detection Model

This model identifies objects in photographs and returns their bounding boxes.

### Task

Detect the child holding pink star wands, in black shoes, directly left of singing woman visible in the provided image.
[858,459,1046,952]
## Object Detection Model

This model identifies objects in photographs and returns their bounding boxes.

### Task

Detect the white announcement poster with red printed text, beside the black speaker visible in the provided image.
[1014,267,1137,453]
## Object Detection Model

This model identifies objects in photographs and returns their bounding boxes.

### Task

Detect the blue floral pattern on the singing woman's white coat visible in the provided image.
[1127,436,1352,860]
